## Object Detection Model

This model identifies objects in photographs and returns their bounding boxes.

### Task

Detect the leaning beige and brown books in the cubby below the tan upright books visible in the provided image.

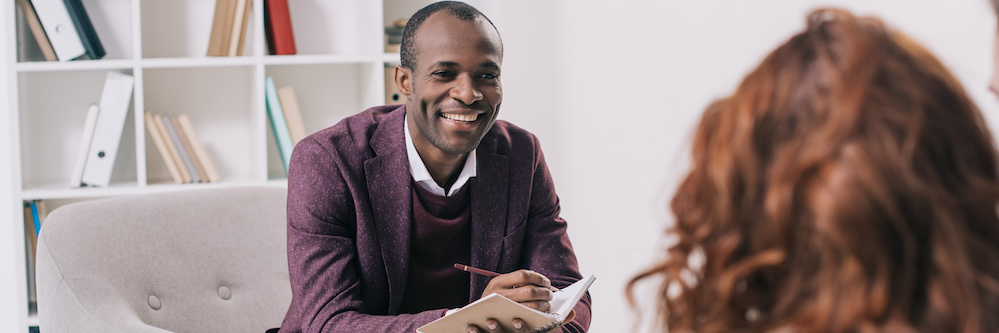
[145,112,219,184]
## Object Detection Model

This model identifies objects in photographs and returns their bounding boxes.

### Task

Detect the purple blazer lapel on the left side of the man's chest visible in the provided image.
[364,107,413,313]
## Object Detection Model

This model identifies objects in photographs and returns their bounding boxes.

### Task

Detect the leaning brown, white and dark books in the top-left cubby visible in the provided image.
[16,0,105,61]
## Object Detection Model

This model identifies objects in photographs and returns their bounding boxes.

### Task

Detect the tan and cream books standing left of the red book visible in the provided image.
[208,0,253,57]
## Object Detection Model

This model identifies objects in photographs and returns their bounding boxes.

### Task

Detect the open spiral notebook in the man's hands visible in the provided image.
[416,274,596,333]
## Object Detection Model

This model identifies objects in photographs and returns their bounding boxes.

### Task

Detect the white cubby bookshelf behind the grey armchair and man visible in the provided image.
[0,0,496,332]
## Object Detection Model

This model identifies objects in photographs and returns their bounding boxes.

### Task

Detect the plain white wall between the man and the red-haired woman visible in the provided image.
[494,0,999,332]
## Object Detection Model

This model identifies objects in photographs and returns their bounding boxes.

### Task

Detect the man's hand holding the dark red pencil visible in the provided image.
[482,269,555,312]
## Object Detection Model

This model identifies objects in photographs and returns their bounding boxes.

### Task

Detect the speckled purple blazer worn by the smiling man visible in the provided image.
[281,106,590,332]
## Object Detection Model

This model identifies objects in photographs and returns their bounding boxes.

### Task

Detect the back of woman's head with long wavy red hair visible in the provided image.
[632,9,999,333]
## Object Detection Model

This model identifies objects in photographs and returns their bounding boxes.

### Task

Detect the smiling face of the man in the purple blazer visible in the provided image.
[396,12,503,159]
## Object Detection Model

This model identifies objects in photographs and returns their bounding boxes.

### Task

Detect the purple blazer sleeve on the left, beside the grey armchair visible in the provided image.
[281,137,444,332]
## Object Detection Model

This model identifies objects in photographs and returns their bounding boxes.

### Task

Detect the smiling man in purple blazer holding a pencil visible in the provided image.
[281,1,590,332]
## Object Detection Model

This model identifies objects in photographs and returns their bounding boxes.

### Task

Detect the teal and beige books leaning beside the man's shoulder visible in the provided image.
[264,77,308,172]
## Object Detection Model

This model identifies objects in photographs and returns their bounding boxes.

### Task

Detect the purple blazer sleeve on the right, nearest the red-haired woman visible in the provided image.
[521,135,591,333]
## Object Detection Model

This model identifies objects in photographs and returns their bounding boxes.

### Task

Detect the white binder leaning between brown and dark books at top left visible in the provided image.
[31,0,86,61]
